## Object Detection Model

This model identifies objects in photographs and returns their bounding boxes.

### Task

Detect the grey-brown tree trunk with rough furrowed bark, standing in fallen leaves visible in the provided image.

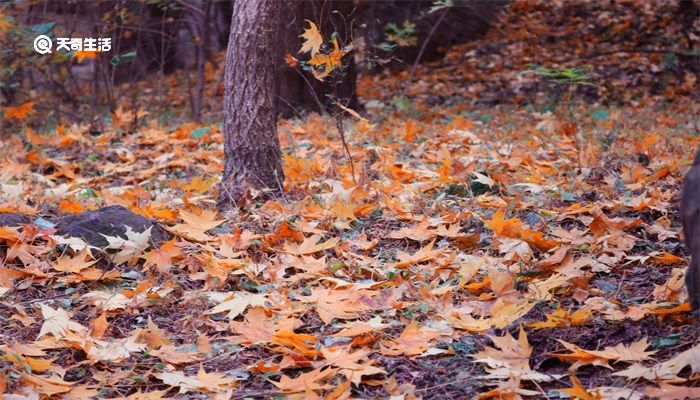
[218,0,284,206]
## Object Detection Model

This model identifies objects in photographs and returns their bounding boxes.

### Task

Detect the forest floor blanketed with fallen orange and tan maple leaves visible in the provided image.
[0,0,700,399]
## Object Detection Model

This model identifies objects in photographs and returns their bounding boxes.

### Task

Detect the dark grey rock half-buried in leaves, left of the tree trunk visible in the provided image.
[56,206,170,247]
